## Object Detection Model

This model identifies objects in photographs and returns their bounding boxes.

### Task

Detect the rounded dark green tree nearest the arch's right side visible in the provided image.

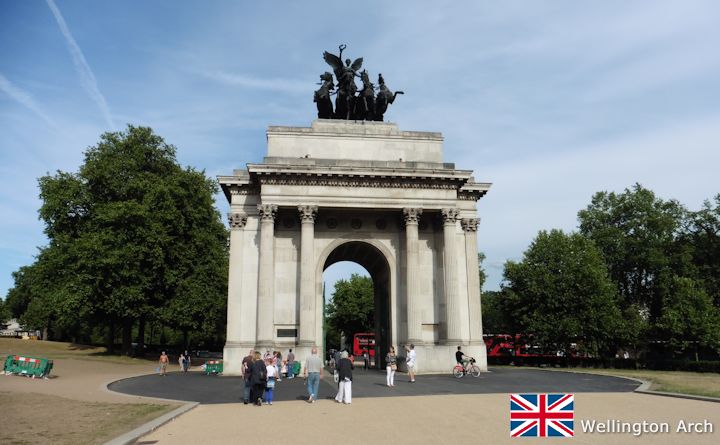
[503,230,622,353]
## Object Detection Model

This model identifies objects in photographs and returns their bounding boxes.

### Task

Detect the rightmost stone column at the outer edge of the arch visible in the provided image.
[460,218,483,345]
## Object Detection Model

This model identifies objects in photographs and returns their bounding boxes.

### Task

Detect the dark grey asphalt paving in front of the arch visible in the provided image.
[109,368,639,404]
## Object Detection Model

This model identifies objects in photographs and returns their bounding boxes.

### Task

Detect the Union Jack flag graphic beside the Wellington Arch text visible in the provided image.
[510,394,575,437]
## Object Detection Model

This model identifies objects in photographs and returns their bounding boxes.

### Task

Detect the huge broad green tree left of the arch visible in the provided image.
[21,126,227,353]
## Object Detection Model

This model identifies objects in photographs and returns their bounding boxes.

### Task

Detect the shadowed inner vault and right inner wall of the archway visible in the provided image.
[319,240,395,368]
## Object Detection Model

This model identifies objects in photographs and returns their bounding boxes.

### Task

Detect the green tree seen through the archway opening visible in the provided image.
[325,274,375,339]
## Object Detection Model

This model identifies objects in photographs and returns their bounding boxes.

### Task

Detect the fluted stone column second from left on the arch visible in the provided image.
[257,204,277,346]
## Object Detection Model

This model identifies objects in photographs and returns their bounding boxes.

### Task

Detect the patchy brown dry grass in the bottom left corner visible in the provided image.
[0,392,175,445]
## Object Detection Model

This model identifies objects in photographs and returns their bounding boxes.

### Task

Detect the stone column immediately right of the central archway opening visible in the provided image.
[403,208,422,345]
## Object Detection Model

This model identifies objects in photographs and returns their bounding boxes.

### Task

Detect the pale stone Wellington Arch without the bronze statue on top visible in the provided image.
[219,119,490,375]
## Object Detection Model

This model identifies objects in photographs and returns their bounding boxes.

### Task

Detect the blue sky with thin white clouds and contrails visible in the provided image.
[0,0,720,296]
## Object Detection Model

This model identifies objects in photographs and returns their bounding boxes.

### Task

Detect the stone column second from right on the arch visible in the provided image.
[441,208,463,343]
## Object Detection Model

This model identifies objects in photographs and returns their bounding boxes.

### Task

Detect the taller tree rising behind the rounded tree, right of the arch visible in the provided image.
[578,184,693,333]
